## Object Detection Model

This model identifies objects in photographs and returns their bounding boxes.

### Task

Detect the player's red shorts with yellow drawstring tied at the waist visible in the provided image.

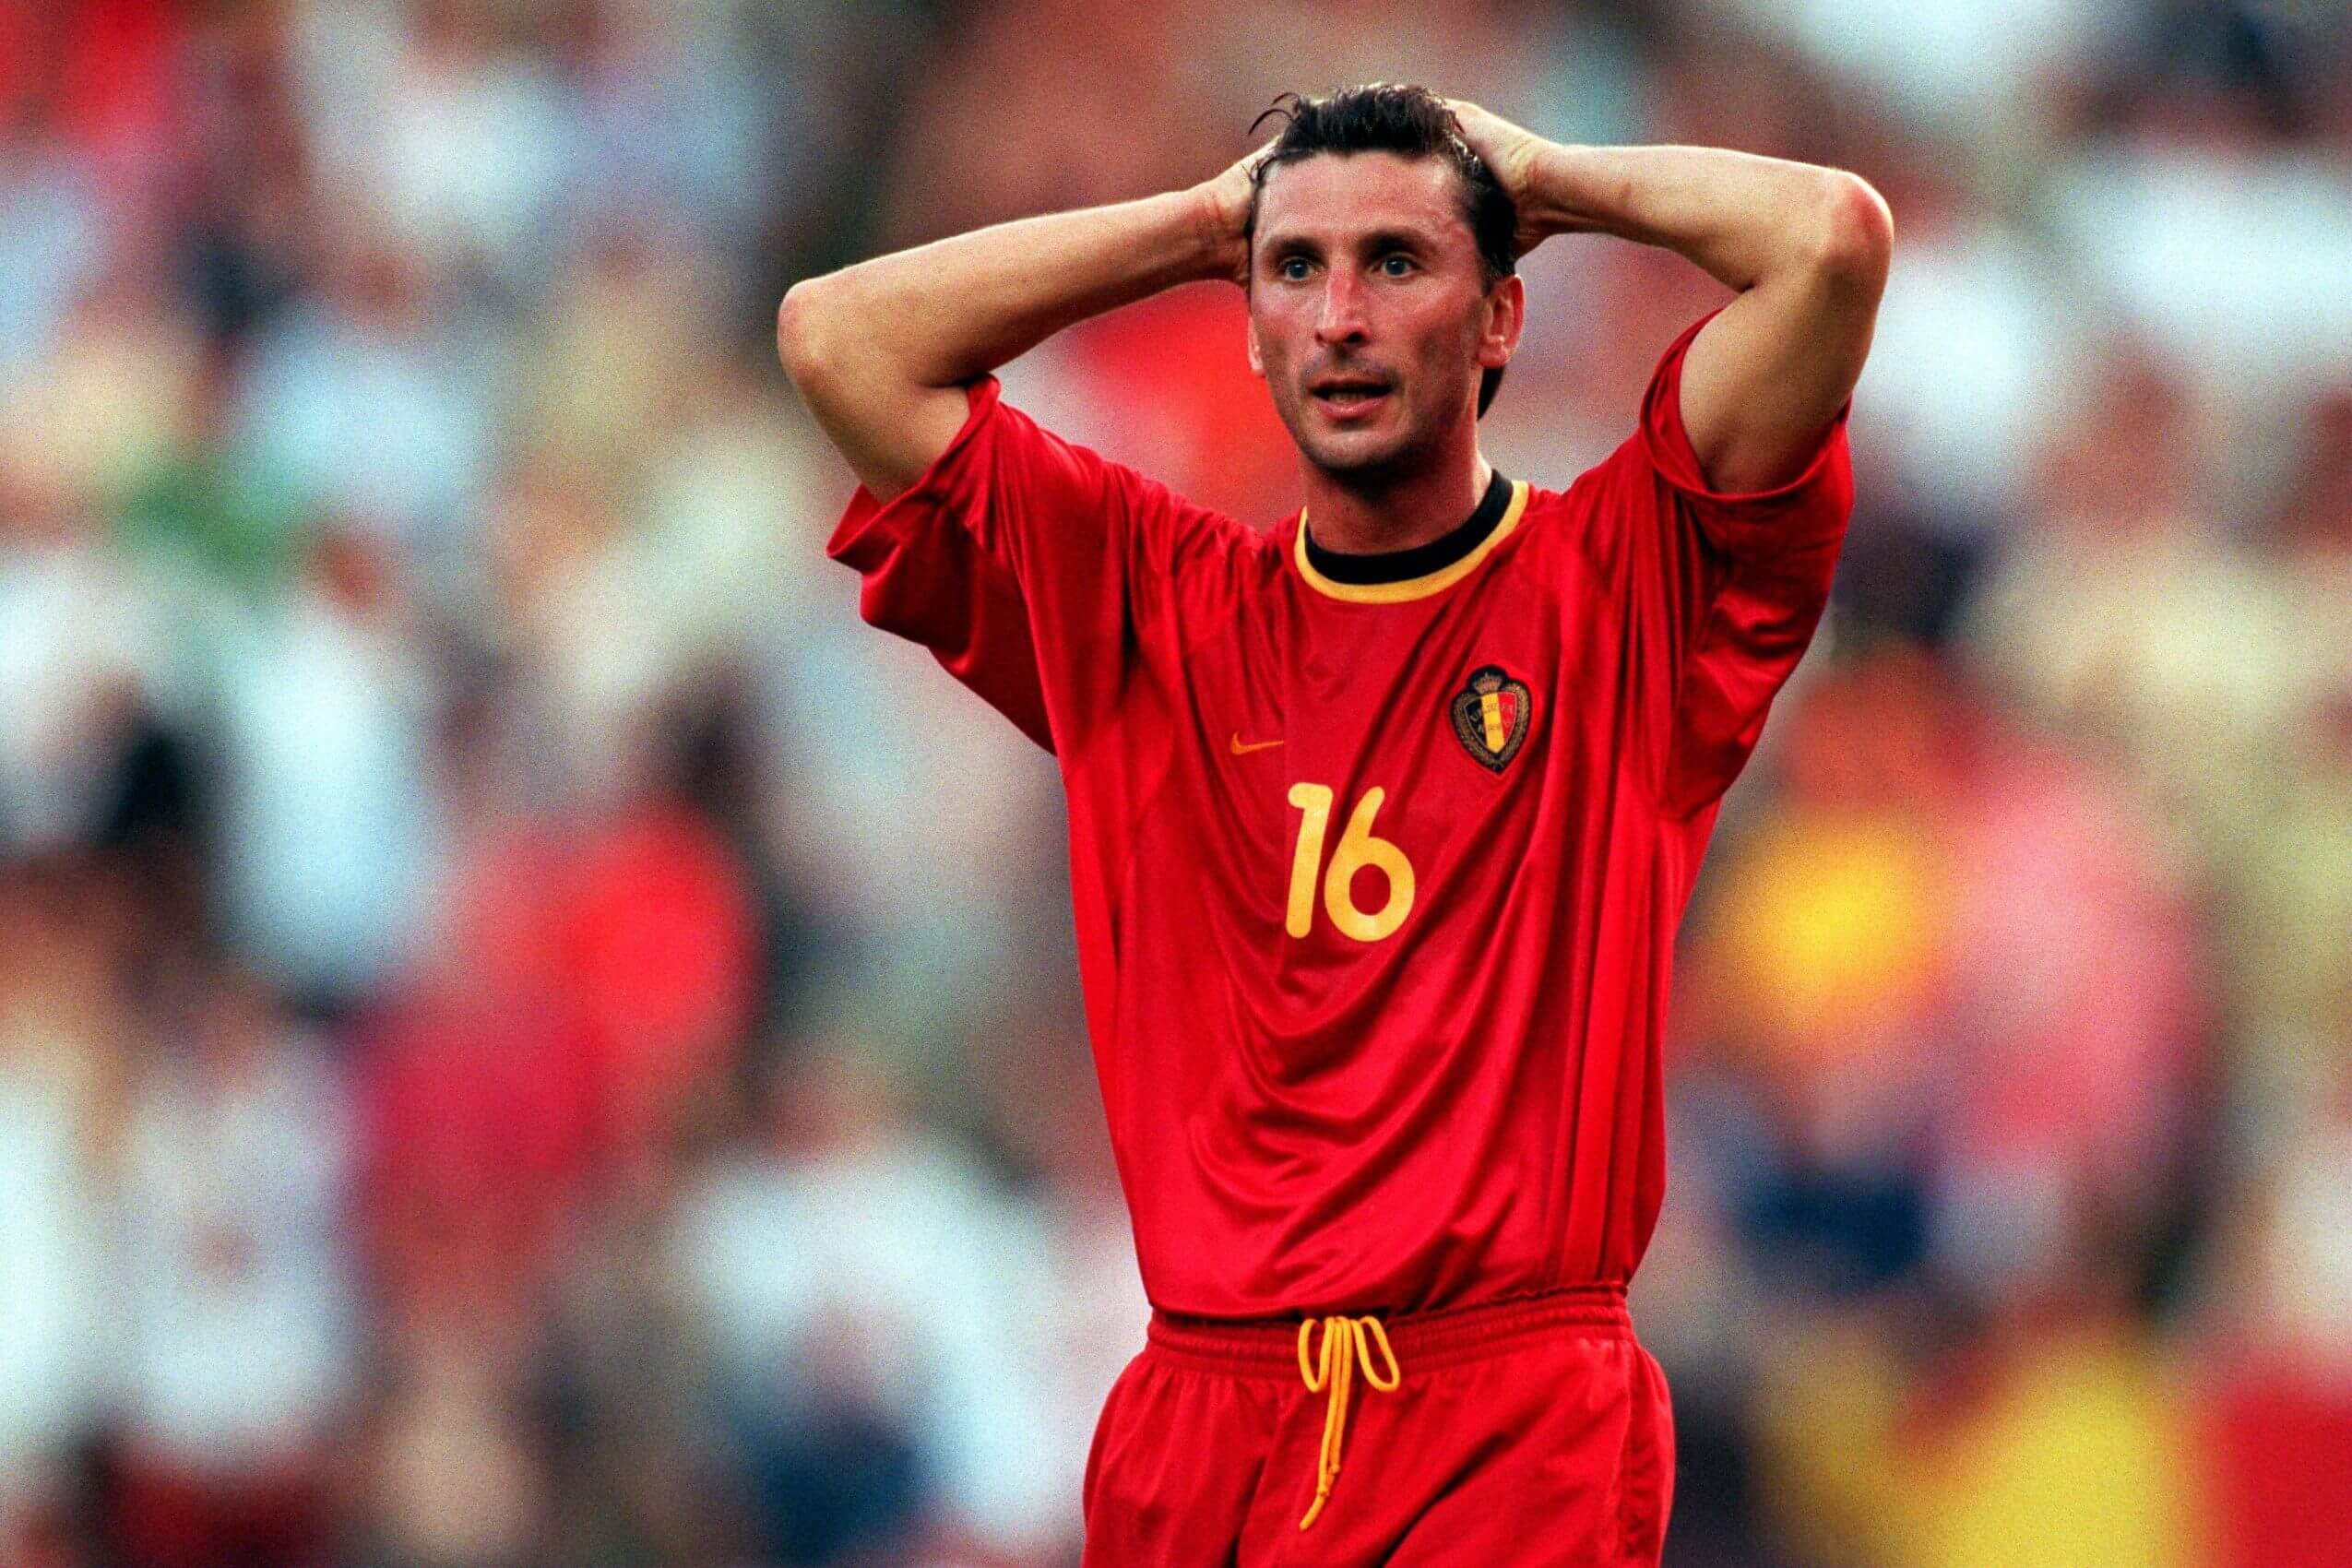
[1085,1286,1675,1568]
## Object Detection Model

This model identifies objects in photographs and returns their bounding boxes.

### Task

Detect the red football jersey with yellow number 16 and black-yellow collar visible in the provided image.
[828,312,1853,1316]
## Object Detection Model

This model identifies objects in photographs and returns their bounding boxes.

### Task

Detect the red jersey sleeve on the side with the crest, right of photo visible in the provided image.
[1611,315,1853,815]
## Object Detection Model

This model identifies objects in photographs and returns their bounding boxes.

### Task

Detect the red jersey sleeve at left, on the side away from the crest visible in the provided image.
[826,376,1240,754]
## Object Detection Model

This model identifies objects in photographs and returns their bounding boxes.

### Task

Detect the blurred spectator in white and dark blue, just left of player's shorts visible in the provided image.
[677,1051,1077,1563]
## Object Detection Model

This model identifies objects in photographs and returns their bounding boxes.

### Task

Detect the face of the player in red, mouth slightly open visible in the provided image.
[1249,153,1519,475]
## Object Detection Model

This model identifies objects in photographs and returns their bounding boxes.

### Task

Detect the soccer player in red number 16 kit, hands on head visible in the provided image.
[778,85,1891,1568]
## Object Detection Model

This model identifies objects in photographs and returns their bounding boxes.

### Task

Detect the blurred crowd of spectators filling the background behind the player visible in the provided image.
[0,0,2352,1568]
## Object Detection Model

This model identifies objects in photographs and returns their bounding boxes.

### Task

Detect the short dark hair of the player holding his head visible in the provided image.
[1244,82,1519,416]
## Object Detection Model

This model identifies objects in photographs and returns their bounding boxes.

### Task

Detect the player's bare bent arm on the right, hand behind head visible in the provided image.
[1454,101,1894,493]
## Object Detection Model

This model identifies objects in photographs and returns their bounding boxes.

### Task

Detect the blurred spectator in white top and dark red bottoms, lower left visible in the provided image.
[120,973,358,1568]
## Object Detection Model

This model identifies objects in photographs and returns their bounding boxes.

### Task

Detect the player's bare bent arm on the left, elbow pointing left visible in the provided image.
[777,158,1249,501]
